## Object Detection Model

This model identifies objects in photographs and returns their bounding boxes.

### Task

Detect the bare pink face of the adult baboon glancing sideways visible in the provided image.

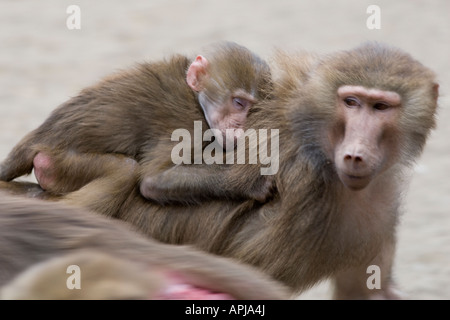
[328,86,401,190]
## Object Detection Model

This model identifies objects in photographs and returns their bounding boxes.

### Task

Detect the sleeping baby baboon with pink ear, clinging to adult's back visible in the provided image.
[0,42,271,203]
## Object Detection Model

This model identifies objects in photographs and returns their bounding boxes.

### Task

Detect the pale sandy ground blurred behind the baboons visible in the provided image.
[0,0,450,299]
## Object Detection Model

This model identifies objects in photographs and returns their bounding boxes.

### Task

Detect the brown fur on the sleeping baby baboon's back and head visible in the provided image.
[0,42,271,202]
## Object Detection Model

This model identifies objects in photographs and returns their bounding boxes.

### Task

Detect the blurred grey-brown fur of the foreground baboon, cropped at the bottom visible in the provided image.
[0,193,288,299]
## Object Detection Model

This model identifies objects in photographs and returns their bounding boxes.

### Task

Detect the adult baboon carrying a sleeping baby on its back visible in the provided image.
[0,43,438,298]
